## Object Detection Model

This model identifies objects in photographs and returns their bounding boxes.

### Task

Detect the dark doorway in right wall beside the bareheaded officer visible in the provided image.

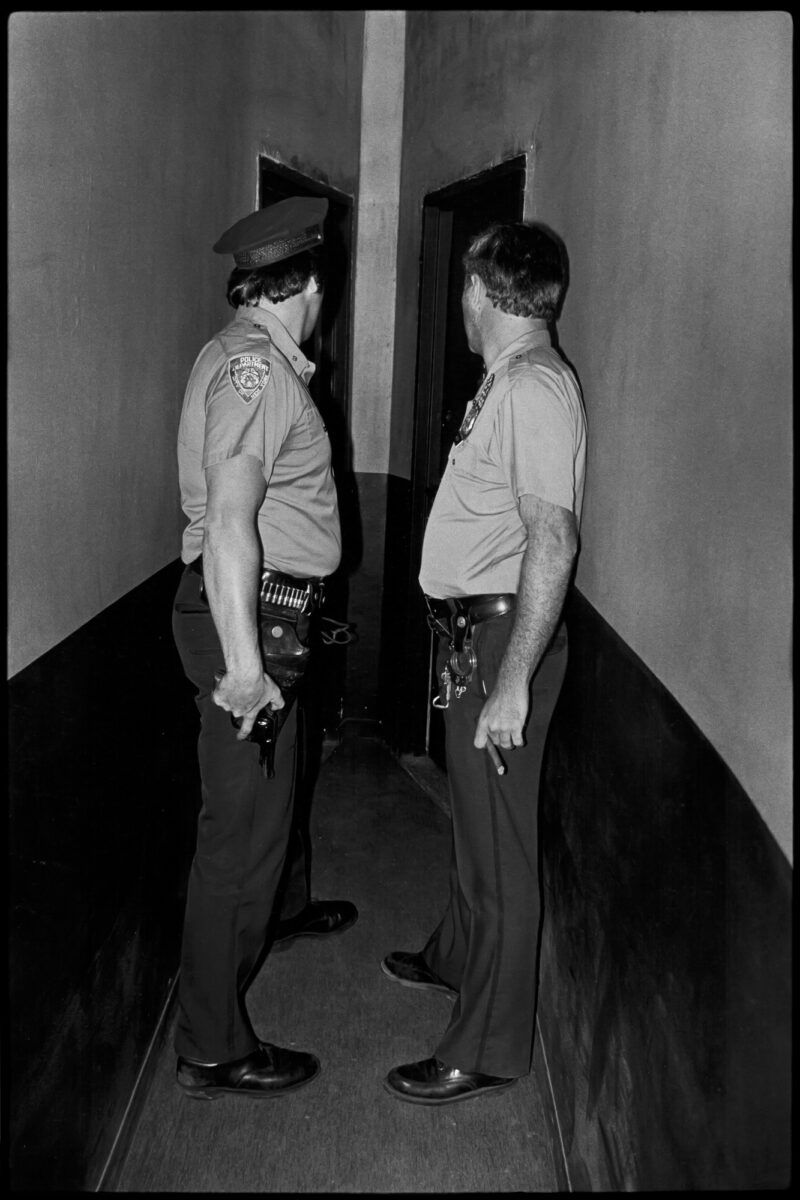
[392,155,525,768]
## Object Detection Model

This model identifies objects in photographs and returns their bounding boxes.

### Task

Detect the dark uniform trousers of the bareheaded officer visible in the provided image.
[422,614,567,1078]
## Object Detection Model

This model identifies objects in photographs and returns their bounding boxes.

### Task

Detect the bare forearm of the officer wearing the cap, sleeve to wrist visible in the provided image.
[203,518,261,680]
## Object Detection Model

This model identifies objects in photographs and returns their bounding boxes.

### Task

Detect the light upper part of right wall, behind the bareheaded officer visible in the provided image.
[390,11,792,858]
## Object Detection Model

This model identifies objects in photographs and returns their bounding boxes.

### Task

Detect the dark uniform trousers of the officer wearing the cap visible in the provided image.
[173,570,307,1062]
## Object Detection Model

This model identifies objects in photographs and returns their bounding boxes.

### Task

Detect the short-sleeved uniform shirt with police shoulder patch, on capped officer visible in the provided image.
[178,307,341,578]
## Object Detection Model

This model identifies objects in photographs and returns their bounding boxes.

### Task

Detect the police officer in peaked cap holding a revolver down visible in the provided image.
[173,197,357,1099]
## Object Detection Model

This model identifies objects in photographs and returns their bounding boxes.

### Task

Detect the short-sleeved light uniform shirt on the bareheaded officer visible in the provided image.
[420,322,587,598]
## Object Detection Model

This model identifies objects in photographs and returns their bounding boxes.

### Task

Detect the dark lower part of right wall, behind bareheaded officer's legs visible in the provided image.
[539,593,792,1190]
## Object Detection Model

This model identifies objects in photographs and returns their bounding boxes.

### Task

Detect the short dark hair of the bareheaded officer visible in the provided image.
[462,221,569,322]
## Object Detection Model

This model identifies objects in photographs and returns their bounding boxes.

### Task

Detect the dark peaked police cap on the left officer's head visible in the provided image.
[213,196,327,268]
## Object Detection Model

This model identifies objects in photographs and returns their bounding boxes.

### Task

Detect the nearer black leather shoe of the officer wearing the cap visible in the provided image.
[178,1042,319,1100]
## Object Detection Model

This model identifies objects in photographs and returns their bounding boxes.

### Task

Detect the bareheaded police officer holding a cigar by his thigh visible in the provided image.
[381,223,585,1104]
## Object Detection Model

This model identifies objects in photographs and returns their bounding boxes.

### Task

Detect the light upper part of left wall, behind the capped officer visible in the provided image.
[8,12,363,674]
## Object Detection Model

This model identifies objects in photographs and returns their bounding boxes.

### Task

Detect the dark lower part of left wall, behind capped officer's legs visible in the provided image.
[8,563,199,1192]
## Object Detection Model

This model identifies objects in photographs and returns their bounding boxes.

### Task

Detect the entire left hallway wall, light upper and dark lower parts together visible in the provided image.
[8,12,363,1190]
